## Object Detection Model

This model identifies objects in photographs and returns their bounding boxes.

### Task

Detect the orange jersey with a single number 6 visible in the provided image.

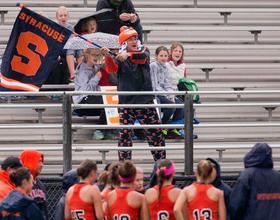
[148,185,176,220]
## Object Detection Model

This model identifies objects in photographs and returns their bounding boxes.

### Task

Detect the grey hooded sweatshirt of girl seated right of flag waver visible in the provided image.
[150,58,175,98]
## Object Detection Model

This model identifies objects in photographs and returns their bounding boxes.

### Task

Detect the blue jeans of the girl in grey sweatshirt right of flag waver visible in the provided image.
[157,95,184,124]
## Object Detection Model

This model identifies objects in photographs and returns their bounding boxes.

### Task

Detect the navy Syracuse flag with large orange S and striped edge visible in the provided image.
[0,7,72,92]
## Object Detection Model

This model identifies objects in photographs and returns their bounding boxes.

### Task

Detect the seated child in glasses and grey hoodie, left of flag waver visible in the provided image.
[73,48,118,140]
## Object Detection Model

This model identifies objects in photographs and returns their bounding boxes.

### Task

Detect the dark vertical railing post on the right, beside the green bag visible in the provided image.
[184,92,193,175]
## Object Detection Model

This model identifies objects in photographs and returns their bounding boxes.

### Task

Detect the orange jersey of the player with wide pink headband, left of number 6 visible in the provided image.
[109,187,140,220]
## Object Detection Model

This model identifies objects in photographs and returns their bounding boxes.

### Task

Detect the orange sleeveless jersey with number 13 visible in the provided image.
[187,183,218,220]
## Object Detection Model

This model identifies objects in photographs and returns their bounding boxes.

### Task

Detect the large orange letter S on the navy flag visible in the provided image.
[11,31,49,76]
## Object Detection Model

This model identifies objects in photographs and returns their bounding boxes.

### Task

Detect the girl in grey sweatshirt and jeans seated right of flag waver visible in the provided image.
[150,46,184,139]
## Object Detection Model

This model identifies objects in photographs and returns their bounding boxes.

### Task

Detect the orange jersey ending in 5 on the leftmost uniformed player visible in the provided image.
[68,183,95,220]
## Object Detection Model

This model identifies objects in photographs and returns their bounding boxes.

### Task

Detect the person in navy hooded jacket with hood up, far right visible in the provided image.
[229,143,280,220]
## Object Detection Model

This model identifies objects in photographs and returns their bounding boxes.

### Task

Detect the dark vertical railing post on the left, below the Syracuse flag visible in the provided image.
[62,93,72,174]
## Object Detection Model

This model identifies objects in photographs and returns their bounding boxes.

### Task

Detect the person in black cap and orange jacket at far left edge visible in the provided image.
[0,156,22,201]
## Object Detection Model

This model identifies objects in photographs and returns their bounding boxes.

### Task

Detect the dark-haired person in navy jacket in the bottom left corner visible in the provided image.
[0,168,44,220]
